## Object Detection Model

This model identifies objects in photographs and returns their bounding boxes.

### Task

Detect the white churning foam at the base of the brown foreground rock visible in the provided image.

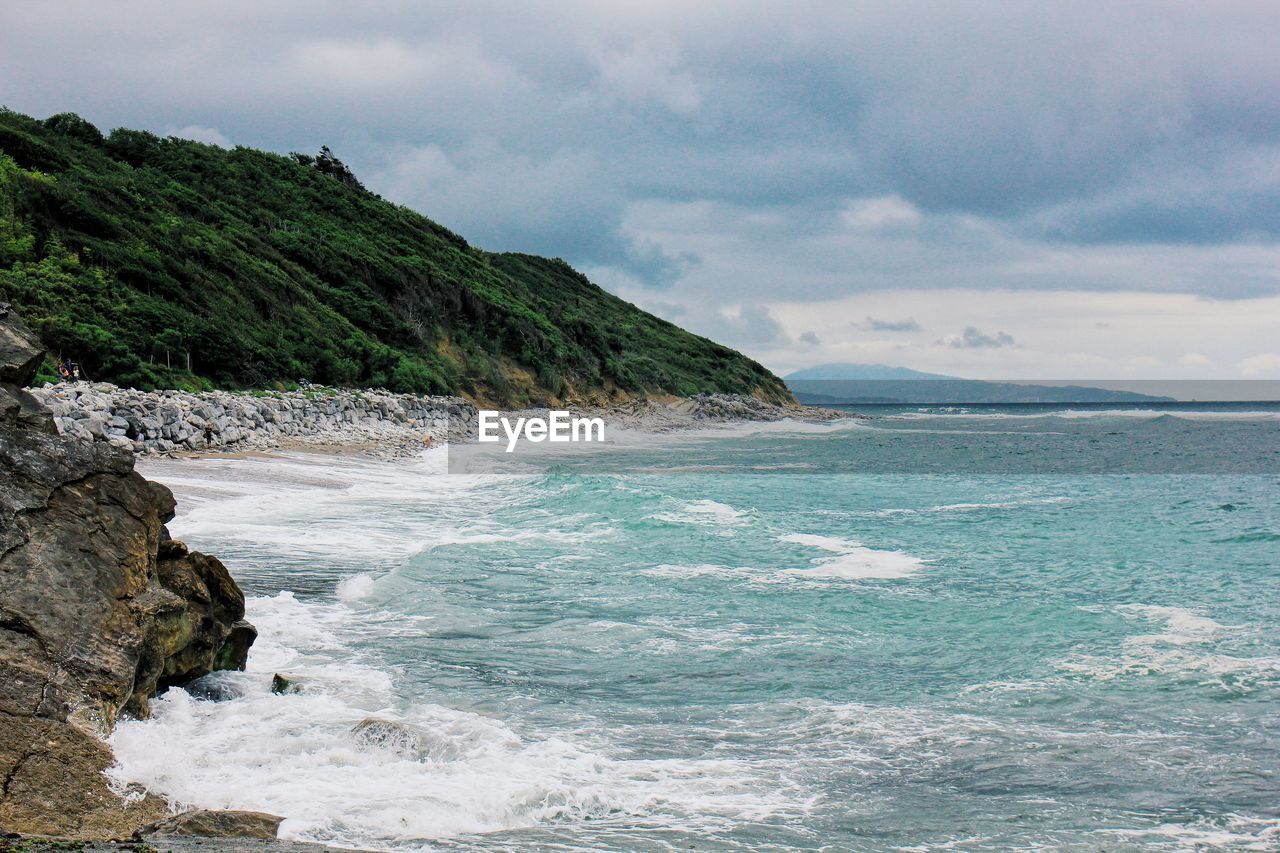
[110,593,801,848]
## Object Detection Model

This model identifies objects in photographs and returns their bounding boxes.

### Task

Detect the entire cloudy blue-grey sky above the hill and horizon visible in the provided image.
[0,0,1280,379]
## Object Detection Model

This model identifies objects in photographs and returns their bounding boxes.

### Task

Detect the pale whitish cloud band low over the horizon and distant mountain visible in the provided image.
[727,289,1280,380]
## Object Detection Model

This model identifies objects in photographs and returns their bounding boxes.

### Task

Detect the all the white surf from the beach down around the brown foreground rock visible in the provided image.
[111,455,797,847]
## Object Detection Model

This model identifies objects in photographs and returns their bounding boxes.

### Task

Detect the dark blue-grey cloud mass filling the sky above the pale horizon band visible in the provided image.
[0,0,1280,295]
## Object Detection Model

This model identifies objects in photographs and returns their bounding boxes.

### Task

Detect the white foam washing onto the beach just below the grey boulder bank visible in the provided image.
[143,450,609,570]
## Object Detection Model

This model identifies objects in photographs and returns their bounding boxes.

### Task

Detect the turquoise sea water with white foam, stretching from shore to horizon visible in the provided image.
[113,406,1280,850]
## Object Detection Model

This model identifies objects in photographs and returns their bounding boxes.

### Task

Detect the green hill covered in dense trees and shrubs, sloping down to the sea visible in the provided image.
[0,110,790,405]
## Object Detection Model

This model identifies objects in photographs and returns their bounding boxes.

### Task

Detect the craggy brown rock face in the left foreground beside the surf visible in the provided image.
[0,304,256,838]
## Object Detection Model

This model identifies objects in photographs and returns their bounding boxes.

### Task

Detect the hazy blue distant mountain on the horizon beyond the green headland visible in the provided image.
[786,364,1174,406]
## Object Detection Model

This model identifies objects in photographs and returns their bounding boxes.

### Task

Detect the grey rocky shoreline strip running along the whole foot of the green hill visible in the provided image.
[31,382,863,459]
